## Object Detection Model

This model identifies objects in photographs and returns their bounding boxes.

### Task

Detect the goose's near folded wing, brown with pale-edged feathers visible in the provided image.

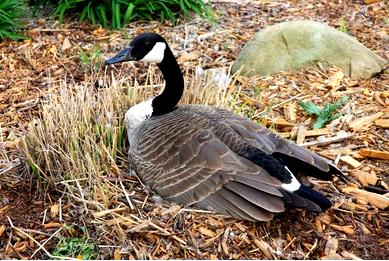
[129,108,284,220]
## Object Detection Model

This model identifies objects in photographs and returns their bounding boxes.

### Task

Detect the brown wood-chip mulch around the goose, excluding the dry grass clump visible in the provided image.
[0,1,389,259]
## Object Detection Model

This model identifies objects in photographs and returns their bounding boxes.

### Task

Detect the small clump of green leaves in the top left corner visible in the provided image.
[0,0,27,40]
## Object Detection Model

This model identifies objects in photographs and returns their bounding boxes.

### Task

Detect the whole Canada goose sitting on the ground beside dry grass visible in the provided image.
[106,33,343,221]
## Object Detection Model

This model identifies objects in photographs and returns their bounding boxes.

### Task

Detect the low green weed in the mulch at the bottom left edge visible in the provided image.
[52,237,98,259]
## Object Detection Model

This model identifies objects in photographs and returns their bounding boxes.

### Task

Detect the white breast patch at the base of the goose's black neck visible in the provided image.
[124,99,153,133]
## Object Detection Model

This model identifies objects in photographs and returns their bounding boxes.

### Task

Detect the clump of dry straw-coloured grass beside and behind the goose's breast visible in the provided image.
[21,66,239,257]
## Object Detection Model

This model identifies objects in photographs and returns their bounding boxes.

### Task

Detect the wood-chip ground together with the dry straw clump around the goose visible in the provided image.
[0,1,389,259]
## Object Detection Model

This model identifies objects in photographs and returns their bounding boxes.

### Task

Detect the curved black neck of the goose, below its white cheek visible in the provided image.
[151,46,184,116]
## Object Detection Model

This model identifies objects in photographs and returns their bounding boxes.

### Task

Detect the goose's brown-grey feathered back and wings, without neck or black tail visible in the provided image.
[129,105,333,221]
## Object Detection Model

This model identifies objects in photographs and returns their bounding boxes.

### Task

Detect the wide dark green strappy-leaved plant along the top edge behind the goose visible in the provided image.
[34,0,211,29]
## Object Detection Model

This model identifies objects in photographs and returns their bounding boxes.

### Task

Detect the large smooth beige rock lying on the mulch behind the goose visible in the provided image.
[232,21,387,79]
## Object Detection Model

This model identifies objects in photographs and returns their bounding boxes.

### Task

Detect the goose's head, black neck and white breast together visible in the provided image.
[105,33,184,133]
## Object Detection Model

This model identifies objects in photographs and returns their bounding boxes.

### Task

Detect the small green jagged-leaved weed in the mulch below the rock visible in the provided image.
[299,96,348,129]
